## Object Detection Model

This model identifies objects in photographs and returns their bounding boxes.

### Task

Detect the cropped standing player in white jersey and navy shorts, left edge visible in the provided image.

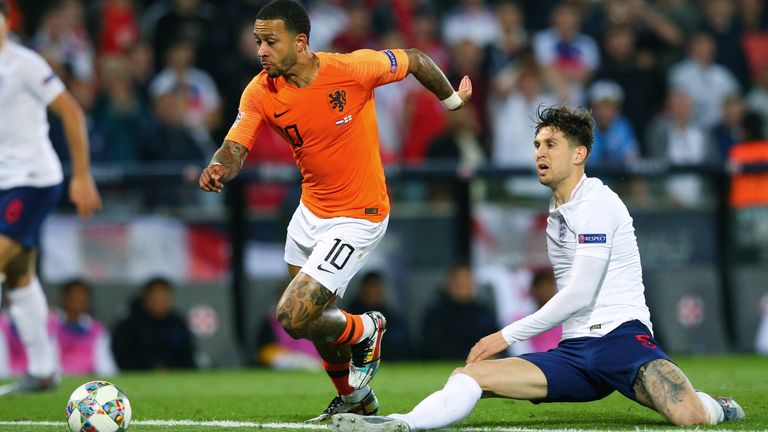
[0,0,101,395]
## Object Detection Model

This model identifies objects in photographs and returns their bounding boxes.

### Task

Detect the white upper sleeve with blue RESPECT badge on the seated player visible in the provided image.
[575,197,618,260]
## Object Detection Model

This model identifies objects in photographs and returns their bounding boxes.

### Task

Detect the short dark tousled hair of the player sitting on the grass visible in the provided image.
[535,105,595,155]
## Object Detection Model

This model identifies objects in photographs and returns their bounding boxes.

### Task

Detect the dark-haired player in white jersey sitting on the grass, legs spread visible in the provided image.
[331,107,745,432]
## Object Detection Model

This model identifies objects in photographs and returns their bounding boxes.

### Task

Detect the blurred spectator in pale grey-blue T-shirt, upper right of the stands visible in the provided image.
[668,33,739,130]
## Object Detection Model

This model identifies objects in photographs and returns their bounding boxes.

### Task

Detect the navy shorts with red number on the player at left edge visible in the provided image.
[0,184,62,249]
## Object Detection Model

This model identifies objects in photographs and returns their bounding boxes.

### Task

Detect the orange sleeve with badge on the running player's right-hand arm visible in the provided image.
[350,49,409,89]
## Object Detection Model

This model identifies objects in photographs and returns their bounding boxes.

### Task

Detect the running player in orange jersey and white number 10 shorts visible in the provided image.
[199,0,472,421]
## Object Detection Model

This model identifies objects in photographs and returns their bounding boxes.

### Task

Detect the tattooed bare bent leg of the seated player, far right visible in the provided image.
[634,359,712,426]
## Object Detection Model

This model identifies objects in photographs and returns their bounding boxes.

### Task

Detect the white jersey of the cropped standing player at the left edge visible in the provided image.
[0,40,64,189]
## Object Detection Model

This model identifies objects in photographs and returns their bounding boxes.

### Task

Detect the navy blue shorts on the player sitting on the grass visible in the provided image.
[519,320,671,402]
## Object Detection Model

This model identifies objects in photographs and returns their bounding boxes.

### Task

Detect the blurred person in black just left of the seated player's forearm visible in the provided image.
[421,263,496,360]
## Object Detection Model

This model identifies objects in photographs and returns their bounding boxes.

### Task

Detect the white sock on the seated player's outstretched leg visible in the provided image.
[387,374,483,430]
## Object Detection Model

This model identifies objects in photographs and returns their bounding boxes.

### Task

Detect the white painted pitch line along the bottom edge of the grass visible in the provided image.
[0,420,760,432]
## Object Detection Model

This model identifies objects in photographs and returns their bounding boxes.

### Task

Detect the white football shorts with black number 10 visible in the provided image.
[285,203,389,297]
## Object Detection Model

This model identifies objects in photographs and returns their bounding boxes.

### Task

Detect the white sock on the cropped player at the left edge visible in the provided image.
[8,277,57,378]
